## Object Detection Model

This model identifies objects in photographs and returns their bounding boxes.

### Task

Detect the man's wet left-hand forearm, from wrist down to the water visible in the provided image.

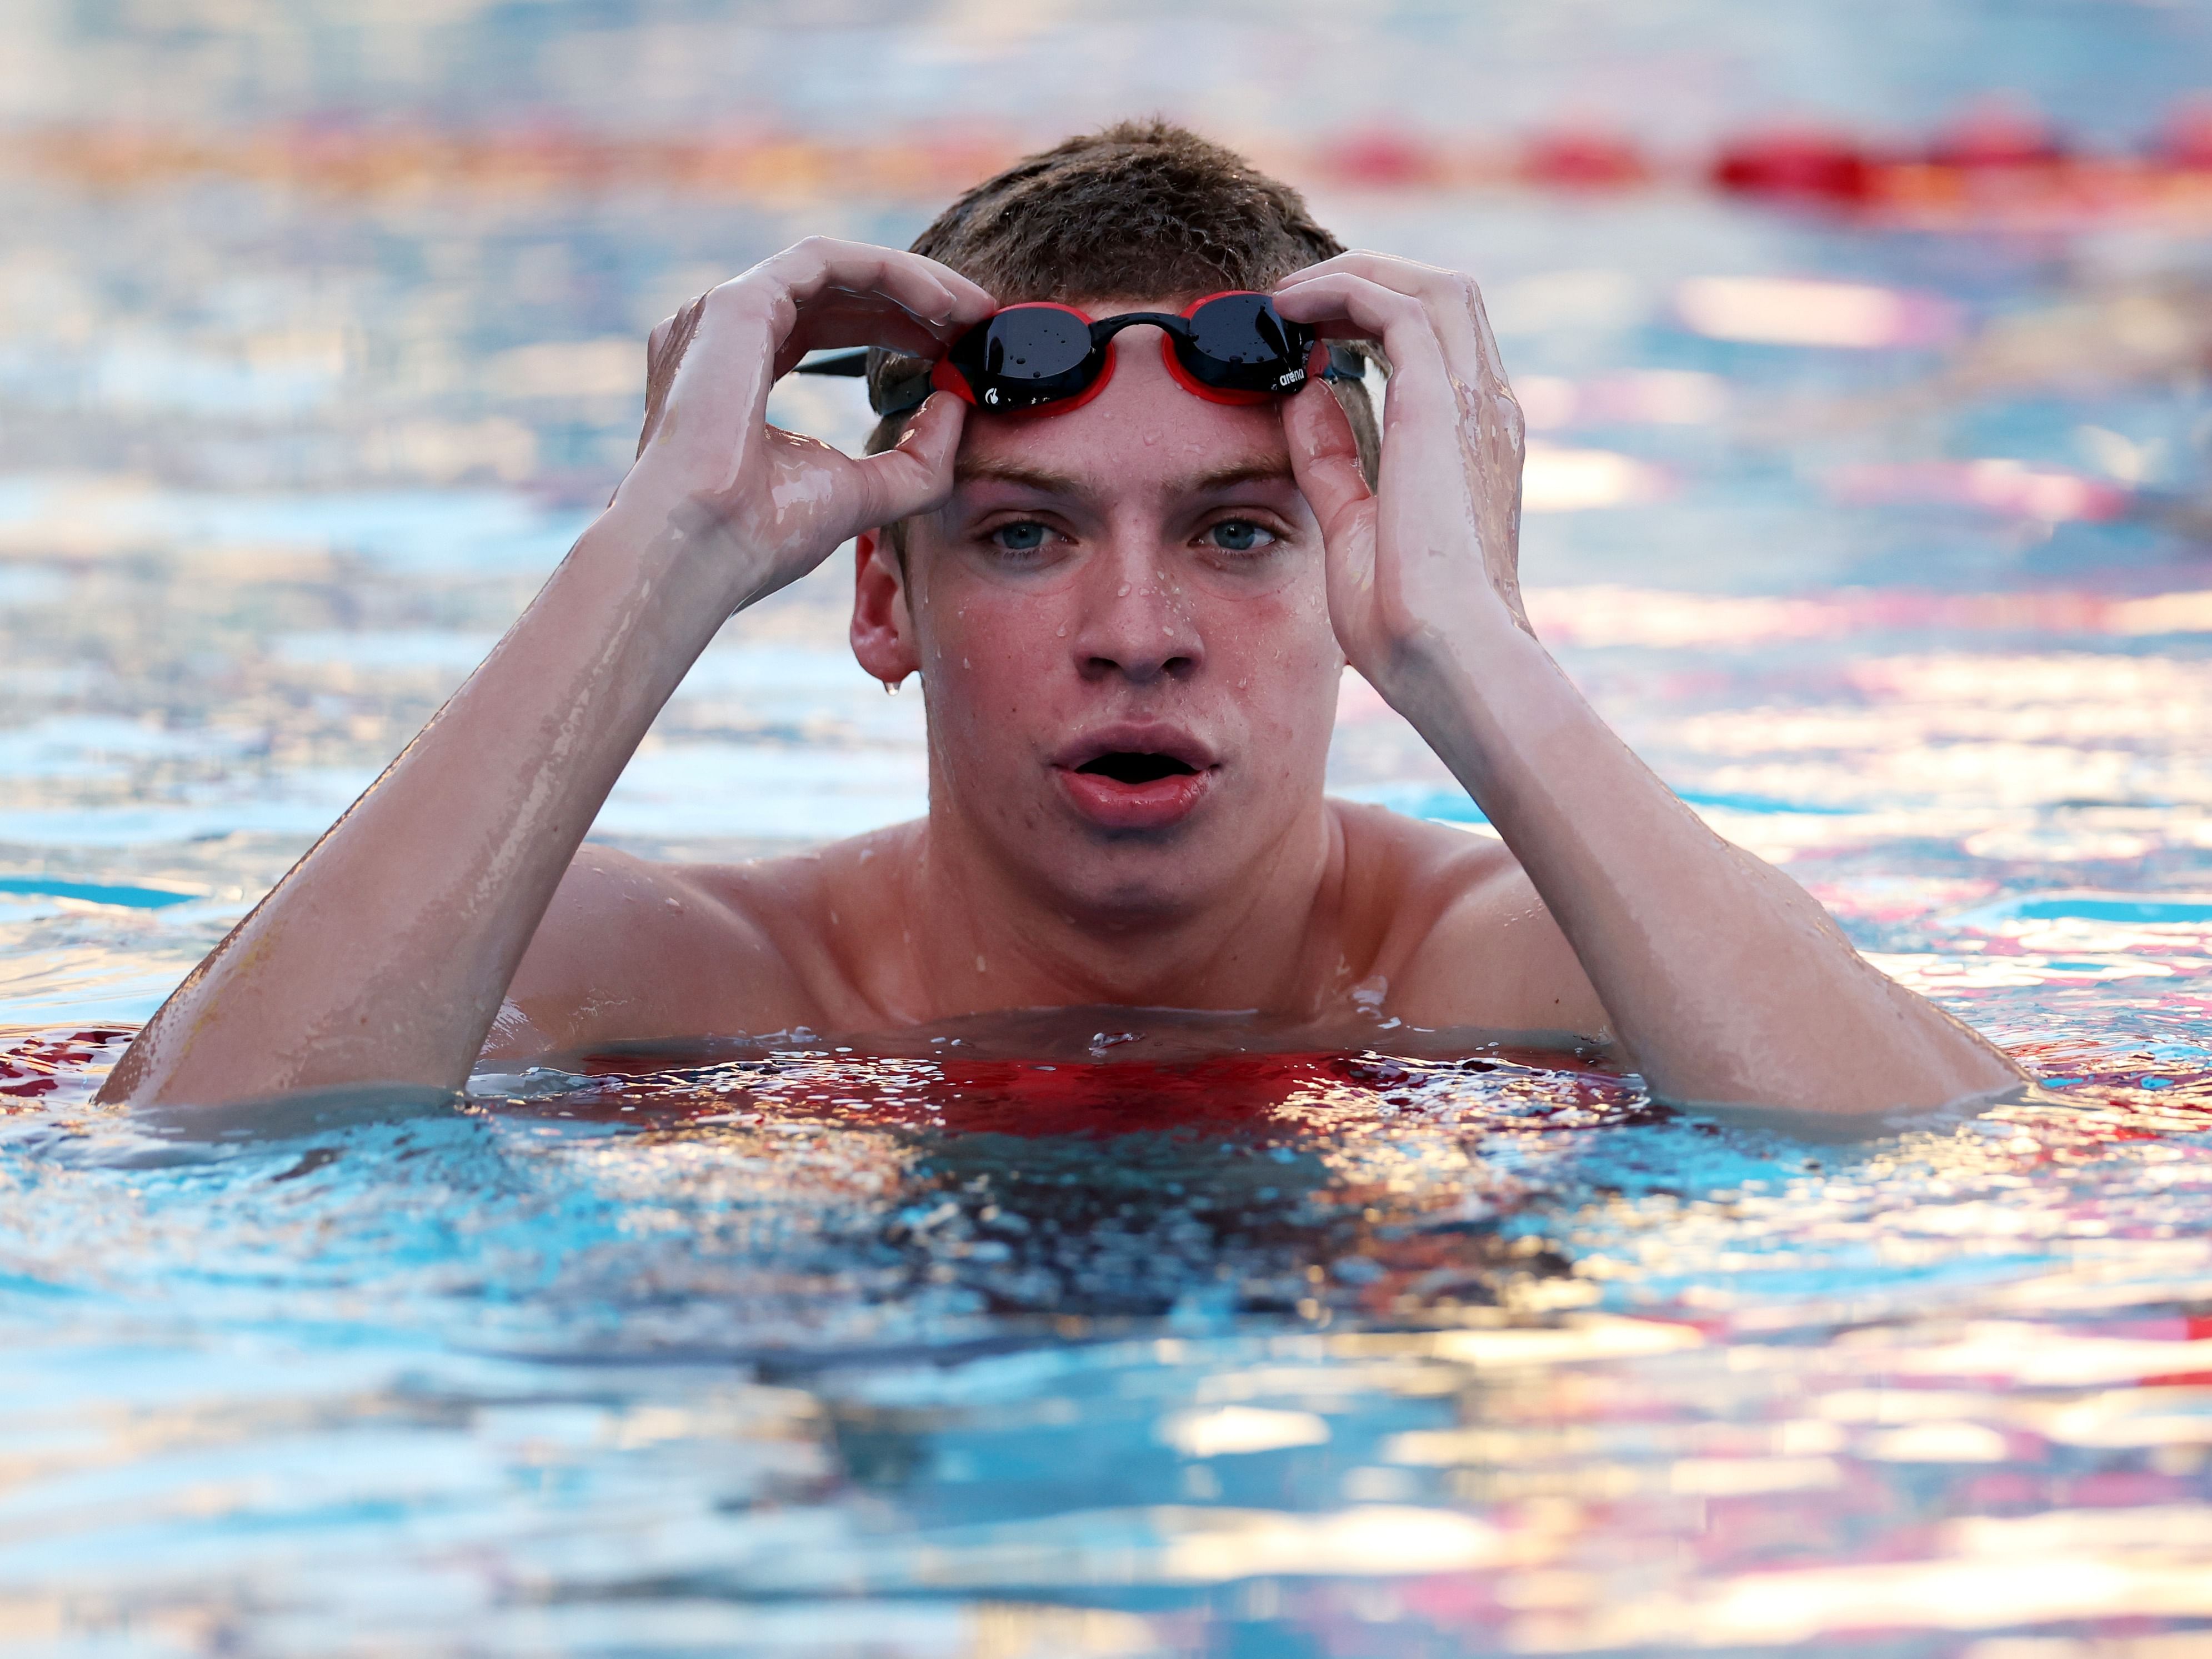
[102,504,732,1104]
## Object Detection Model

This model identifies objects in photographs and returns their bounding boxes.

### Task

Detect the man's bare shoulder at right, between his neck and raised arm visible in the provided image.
[1334,801,1610,1037]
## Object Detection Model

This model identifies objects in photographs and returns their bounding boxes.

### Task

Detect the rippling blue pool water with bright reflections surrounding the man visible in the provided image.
[0,0,2212,1659]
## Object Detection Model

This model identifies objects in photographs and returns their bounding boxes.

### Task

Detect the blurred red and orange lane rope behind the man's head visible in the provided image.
[17,99,2212,230]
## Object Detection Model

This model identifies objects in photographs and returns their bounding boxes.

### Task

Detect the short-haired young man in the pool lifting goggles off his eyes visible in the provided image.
[104,126,2020,1110]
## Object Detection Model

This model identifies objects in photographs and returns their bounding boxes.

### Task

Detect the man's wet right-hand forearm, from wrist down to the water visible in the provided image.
[1392,606,2020,1110]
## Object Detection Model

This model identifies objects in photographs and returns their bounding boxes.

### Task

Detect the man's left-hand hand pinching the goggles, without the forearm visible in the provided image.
[615,237,998,610]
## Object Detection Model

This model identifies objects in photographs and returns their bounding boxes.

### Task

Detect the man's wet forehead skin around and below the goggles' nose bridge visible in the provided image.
[960,299,1290,495]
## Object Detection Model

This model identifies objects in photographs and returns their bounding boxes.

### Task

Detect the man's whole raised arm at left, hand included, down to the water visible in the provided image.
[102,239,993,1104]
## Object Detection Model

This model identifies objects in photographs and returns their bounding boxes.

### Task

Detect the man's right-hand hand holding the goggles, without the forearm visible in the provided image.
[1274,252,1529,697]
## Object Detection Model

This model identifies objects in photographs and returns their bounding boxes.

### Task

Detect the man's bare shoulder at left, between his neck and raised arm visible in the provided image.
[484,836,915,1057]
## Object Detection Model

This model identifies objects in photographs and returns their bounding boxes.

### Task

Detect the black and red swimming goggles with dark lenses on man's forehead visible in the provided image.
[799,290,1365,416]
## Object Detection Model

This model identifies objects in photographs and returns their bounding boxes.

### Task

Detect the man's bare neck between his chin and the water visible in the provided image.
[905,790,1345,1020]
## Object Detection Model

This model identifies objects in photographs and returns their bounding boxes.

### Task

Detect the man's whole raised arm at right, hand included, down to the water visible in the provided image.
[1277,254,2022,1110]
